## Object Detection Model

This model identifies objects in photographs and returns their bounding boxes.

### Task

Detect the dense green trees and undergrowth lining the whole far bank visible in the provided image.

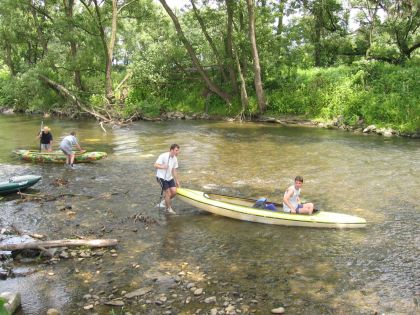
[0,0,420,132]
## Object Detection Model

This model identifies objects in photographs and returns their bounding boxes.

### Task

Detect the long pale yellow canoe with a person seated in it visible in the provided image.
[177,188,366,228]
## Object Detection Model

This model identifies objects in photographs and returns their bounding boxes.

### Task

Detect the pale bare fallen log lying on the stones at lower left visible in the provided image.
[0,239,118,250]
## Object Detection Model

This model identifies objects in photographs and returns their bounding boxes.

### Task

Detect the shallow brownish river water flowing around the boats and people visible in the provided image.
[0,116,420,314]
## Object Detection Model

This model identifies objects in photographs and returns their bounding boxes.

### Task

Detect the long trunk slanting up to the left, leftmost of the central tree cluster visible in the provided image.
[159,0,231,105]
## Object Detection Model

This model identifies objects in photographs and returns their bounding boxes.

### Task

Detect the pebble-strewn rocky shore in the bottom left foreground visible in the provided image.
[0,229,286,315]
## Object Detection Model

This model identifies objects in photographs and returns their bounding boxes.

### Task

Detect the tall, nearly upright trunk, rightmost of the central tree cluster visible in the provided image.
[247,0,266,114]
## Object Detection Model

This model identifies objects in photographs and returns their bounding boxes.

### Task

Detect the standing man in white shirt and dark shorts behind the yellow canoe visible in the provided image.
[154,143,180,214]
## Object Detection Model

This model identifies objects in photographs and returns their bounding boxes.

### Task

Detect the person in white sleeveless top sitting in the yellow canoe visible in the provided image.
[283,176,314,214]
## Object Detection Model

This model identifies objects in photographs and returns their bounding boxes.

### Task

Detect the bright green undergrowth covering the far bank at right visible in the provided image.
[267,62,420,131]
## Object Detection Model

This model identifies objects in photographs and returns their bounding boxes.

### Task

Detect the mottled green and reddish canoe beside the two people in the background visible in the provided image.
[13,150,107,163]
